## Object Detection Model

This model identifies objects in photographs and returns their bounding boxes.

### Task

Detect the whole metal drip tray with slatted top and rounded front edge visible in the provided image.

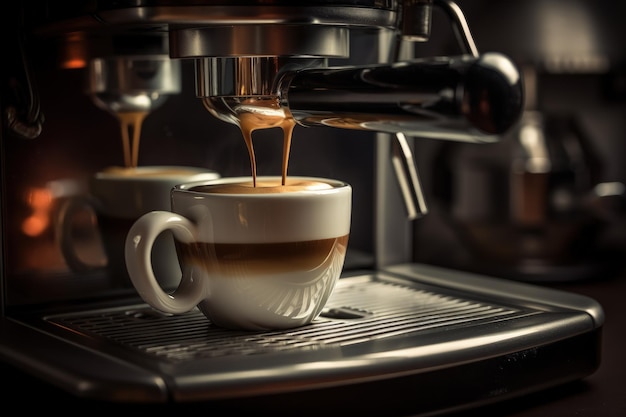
[7,264,603,415]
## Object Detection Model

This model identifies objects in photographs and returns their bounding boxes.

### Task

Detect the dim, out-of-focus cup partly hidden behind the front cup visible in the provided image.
[56,165,219,287]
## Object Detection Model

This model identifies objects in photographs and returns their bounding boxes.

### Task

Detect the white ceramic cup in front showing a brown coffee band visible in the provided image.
[126,177,352,330]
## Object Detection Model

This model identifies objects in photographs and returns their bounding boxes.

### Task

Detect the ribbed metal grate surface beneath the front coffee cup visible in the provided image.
[47,277,540,362]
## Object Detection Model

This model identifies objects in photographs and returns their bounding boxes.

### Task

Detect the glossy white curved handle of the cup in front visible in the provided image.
[125,211,205,314]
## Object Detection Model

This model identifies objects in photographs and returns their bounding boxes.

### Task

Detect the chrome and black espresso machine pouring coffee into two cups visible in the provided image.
[0,0,603,415]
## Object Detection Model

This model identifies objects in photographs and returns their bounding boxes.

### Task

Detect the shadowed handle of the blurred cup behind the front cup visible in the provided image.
[54,196,103,273]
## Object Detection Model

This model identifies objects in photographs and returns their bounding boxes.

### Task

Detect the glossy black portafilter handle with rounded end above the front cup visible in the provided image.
[279,53,524,142]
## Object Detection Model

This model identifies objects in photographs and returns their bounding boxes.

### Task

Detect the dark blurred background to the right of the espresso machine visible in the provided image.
[414,0,626,282]
